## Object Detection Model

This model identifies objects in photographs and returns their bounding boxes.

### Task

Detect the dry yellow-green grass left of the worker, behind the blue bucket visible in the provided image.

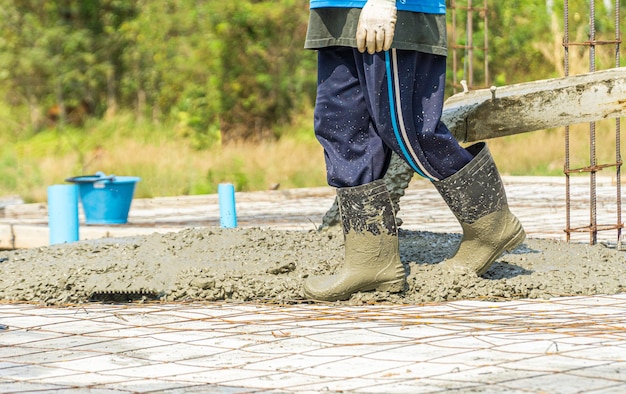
[0,108,325,202]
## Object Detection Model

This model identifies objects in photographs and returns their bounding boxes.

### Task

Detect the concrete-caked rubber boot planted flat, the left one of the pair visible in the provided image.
[304,180,406,301]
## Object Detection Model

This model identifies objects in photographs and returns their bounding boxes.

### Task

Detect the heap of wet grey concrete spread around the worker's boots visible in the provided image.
[0,228,626,305]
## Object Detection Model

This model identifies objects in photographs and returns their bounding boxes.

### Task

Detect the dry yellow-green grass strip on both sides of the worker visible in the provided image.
[0,108,615,202]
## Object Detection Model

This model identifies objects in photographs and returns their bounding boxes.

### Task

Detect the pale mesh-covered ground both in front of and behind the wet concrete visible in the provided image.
[0,177,626,393]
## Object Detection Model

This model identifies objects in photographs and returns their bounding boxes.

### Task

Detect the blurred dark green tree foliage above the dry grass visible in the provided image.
[0,0,614,144]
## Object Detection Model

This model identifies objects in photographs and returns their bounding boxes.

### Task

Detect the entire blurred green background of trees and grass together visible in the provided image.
[0,0,623,201]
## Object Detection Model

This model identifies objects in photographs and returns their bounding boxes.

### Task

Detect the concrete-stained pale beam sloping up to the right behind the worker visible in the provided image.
[442,67,626,142]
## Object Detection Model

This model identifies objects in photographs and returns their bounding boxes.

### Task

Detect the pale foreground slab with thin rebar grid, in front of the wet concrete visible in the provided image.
[0,294,626,393]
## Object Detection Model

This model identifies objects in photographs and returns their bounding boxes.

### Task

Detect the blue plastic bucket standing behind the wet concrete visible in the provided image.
[66,172,141,224]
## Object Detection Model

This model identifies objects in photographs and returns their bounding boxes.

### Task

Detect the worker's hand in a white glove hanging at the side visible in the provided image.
[356,0,397,55]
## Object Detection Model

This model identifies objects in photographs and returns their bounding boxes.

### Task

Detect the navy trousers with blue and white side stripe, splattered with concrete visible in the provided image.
[314,47,473,188]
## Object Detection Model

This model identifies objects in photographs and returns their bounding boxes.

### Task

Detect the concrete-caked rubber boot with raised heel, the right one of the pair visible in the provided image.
[433,142,526,276]
